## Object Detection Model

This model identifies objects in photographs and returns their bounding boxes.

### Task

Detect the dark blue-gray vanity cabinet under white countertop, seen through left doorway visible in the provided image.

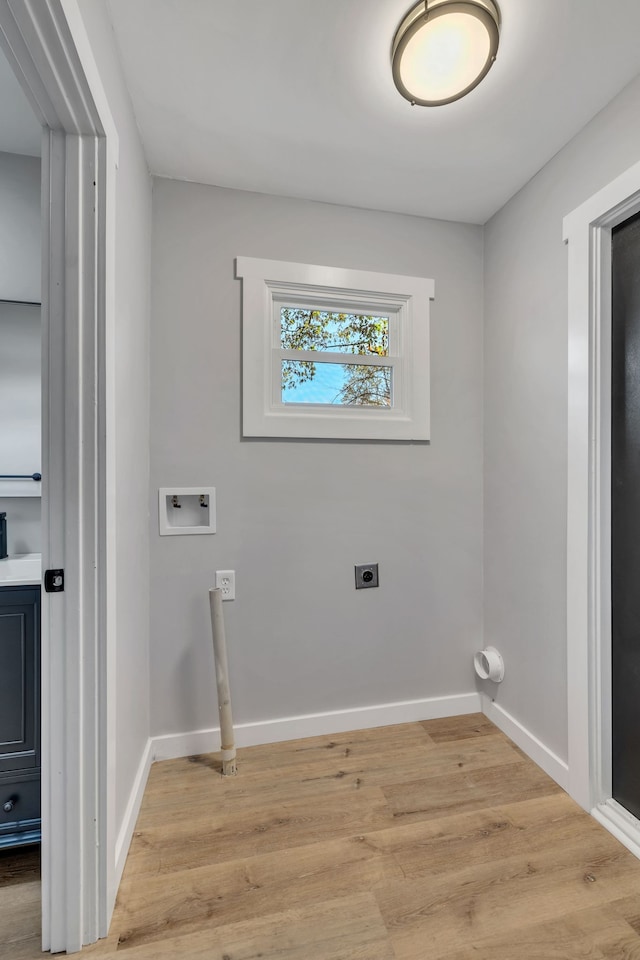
[0,586,40,848]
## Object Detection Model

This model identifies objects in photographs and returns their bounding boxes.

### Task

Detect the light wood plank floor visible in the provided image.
[0,715,640,960]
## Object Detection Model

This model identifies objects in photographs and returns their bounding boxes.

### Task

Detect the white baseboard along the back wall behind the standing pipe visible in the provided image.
[152,692,482,760]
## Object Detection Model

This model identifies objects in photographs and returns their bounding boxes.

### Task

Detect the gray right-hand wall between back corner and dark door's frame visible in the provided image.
[484,79,640,757]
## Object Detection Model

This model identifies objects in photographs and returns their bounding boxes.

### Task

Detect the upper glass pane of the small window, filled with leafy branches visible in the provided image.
[280,307,389,357]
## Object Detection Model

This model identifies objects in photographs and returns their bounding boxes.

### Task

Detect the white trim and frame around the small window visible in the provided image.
[236,257,434,440]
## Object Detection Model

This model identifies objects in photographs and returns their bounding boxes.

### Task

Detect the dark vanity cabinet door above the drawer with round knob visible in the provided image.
[0,587,40,775]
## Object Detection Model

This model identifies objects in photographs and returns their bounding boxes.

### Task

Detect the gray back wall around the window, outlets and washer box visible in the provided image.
[150,180,483,734]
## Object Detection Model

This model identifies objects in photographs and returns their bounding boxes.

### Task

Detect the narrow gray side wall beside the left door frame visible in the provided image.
[79,0,151,840]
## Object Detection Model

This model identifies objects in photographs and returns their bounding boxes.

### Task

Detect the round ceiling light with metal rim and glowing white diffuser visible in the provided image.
[391,0,500,107]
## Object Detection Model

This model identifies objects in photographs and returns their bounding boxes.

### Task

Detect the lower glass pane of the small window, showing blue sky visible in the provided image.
[282,360,392,407]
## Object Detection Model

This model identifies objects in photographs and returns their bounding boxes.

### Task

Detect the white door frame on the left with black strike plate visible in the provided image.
[0,0,118,952]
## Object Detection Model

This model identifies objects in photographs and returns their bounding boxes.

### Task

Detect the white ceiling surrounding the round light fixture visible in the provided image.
[109,0,640,223]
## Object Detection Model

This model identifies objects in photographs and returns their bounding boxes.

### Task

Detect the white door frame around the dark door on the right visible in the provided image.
[563,163,640,853]
